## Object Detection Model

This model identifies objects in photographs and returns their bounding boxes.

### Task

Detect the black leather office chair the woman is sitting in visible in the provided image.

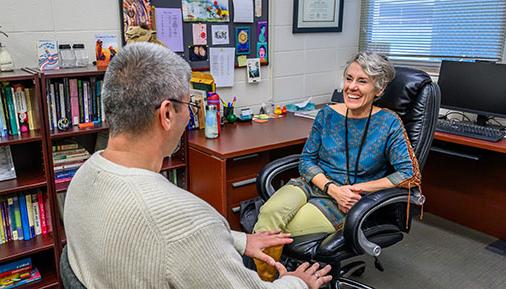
[257,67,440,289]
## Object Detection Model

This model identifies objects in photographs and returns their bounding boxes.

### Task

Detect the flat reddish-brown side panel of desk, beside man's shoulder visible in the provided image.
[188,147,227,218]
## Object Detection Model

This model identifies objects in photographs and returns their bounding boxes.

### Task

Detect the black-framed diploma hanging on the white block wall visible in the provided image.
[292,0,344,33]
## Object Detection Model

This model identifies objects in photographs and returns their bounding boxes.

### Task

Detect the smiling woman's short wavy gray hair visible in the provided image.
[344,51,395,96]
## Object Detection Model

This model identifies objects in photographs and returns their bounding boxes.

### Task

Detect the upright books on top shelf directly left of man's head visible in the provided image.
[46,77,105,130]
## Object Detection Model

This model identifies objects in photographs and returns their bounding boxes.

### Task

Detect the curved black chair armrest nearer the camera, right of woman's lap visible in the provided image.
[343,188,425,256]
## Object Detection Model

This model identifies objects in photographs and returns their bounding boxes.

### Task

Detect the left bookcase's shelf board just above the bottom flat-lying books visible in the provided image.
[0,233,54,263]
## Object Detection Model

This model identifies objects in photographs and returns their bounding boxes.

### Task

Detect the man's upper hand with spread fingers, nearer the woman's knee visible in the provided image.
[244,230,293,266]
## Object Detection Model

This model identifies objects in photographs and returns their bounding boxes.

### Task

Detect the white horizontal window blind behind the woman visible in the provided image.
[360,0,506,66]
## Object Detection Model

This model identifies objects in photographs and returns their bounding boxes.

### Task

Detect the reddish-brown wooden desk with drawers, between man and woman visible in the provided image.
[188,115,313,229]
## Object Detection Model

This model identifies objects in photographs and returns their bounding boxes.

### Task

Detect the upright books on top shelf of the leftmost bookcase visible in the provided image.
[0,82,39,137]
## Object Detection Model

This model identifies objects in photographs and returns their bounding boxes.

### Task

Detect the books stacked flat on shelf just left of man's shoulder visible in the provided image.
[53,143,90,184]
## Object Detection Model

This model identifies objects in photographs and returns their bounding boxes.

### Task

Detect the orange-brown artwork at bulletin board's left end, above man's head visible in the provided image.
[122,0,153,39]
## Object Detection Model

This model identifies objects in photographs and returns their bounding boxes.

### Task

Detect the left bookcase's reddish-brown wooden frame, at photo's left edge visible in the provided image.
[0,70,60,288]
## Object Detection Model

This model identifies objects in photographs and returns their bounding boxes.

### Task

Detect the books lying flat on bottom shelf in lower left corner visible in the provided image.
[0,258,41,289]
